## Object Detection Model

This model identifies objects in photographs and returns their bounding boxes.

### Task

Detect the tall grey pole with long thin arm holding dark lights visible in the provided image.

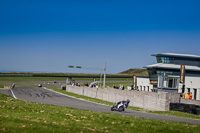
[68,62,107,88]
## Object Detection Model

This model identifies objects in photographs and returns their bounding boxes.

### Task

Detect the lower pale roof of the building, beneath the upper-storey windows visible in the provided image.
[145,63,200,71]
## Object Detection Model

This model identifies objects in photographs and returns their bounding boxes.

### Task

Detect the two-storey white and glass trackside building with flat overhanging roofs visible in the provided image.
[138,53,200,100]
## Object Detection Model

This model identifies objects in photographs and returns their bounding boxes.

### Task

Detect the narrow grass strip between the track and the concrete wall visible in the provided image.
[48,87,200,120]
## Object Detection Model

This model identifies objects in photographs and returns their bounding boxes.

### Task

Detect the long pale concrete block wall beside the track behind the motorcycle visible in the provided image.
[66,85,170,111]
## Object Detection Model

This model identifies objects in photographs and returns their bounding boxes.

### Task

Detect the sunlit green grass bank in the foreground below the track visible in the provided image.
[0,94,200,133]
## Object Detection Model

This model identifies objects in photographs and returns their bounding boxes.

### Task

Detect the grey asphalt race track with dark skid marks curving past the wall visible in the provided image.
[0,87,200,124]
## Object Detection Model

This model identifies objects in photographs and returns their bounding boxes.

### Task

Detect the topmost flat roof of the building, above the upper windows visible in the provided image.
[152,53,200,59]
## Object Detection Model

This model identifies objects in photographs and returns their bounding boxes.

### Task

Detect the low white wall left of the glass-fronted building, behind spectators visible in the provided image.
[137,77,153,91]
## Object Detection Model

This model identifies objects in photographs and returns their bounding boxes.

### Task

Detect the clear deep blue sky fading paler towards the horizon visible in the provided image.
[0,0,200,73]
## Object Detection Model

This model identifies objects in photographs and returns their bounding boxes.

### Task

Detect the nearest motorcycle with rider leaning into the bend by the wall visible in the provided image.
[111,99,130,112]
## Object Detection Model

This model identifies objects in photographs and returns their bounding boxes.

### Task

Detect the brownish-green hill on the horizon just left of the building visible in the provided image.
[118,68,148,76]
